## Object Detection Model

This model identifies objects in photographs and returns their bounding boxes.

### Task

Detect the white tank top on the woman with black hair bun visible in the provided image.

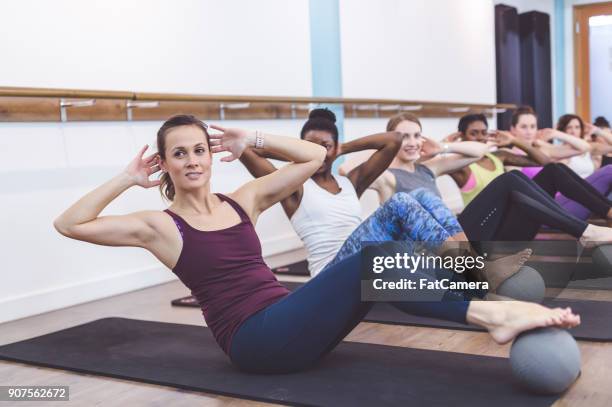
[291,176,362,277]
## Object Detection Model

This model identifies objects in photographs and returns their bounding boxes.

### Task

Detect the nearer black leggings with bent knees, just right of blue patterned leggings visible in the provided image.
[458,171,588,242]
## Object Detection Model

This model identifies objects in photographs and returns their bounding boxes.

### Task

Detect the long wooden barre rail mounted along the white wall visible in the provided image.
[0,87,516,122]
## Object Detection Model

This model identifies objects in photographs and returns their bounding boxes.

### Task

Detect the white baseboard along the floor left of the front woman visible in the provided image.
[0,265,177,323]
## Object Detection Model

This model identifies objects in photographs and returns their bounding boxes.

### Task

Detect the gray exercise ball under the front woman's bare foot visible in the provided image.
[510,328,580,394]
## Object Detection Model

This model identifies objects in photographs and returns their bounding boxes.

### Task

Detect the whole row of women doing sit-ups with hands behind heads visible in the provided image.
[54,109,612,373]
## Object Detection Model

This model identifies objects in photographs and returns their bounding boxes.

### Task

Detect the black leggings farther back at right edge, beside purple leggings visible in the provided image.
[533,163,612,218]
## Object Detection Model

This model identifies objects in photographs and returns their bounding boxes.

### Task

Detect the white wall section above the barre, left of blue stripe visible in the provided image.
[0,0,311,96]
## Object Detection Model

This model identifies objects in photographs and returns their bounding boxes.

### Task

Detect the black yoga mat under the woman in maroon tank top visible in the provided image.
[0,318,557,407]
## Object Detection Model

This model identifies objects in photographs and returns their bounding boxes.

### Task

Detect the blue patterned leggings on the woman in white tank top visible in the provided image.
[326,188,463,268]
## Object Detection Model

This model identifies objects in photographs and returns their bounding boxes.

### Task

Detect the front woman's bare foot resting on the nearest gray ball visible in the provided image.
[467,301,580,344]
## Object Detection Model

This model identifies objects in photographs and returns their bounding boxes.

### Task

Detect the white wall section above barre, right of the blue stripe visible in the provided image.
[340,0,496,103]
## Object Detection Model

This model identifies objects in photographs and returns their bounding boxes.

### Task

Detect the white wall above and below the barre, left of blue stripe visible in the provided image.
[0,0,312,322]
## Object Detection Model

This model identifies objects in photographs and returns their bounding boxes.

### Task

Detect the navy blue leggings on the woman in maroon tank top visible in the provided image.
[230,246,469,373]
